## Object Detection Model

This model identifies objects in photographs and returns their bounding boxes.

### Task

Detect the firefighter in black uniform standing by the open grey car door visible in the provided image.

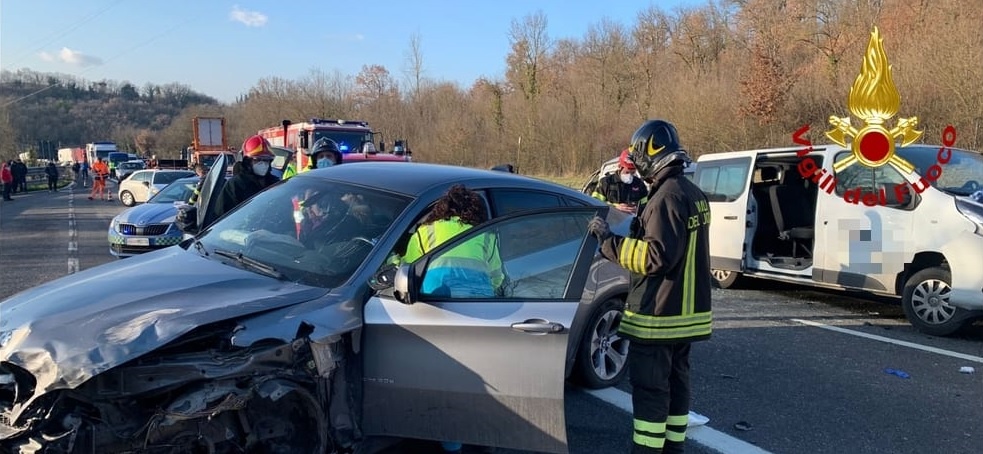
[588,120,712,454]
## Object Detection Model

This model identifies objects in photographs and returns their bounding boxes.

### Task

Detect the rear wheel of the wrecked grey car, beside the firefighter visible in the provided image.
[574,299,628,389]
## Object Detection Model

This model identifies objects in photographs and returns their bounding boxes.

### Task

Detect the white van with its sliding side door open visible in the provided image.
[694,145,983,336]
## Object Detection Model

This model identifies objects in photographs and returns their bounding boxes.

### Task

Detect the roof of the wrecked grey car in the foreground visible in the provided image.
[298,161,597,201]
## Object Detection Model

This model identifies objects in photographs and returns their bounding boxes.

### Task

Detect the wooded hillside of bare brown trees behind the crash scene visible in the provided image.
[0,0,983,174]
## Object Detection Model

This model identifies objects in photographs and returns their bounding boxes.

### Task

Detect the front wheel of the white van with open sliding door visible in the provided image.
[901,267,973,336]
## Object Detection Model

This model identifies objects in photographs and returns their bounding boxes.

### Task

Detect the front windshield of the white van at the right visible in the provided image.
[897,146,983,195]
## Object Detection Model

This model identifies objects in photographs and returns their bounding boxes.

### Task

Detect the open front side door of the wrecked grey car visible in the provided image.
[363,207,607,453]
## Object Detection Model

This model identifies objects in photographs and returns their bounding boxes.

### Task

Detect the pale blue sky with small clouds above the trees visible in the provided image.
[0,0,705,102]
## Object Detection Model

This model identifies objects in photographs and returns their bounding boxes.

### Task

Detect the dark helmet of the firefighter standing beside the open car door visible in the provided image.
[628,120,690,178]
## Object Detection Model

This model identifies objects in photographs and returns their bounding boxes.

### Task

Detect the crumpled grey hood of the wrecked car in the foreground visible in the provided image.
[0,248,327,396]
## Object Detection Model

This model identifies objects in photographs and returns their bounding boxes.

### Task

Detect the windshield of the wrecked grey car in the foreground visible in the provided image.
[199,174,411,288]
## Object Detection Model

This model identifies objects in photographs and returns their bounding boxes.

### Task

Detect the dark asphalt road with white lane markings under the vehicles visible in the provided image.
[0,179,983,454]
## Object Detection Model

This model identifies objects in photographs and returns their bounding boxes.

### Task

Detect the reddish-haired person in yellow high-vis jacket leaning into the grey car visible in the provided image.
[402,185,505,298]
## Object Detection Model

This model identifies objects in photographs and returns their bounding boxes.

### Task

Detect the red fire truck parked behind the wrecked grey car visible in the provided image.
[259,118,411,169]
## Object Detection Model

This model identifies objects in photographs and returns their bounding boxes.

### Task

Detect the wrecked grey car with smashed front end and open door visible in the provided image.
[0,162,629,453]
